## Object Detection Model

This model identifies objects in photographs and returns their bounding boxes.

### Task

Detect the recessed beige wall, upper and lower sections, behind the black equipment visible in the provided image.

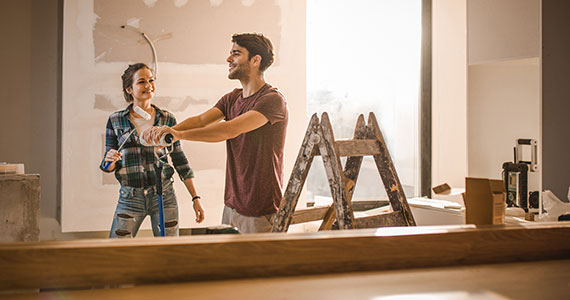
[467,0,541,191]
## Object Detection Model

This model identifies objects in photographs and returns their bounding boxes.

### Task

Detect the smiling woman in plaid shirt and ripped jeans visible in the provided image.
[100,63,204,238]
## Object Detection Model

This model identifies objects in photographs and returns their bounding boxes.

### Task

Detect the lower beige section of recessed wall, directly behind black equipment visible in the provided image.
[467,58,540,191]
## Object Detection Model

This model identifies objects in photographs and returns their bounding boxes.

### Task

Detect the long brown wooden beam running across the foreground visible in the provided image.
[0,223,570,290]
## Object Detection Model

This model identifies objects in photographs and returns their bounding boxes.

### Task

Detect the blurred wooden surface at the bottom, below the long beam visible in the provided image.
[4,260,570,300]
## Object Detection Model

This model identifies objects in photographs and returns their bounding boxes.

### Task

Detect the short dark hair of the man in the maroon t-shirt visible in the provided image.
[232,33,274,72]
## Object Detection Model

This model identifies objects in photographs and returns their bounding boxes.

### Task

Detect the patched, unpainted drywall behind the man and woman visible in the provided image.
[61,0,306,232]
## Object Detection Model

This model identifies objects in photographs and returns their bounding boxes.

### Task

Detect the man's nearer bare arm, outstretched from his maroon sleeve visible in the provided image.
[169,108,269,142]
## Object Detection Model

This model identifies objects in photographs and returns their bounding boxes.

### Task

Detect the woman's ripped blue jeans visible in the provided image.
[109,178,179,238]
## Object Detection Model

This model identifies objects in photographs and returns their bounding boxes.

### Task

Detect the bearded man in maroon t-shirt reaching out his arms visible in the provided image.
[143,33,289,233]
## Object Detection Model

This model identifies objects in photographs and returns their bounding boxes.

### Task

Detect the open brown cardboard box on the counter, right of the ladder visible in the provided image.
[465,177,506,225]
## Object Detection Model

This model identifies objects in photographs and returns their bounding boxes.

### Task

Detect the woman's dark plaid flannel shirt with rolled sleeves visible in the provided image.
[99,104,194,188]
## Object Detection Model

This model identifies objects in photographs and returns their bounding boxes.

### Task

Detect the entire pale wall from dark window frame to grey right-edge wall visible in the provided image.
[432,0,541,190]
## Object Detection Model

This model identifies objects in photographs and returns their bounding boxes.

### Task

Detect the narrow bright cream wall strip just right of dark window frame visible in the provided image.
[432,0,467,188]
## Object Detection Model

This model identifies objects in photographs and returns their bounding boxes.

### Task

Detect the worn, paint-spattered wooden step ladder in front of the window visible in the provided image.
[272,112,416,232]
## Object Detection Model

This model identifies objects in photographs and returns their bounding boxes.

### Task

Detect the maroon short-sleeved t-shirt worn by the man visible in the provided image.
[215,84,289,217]
